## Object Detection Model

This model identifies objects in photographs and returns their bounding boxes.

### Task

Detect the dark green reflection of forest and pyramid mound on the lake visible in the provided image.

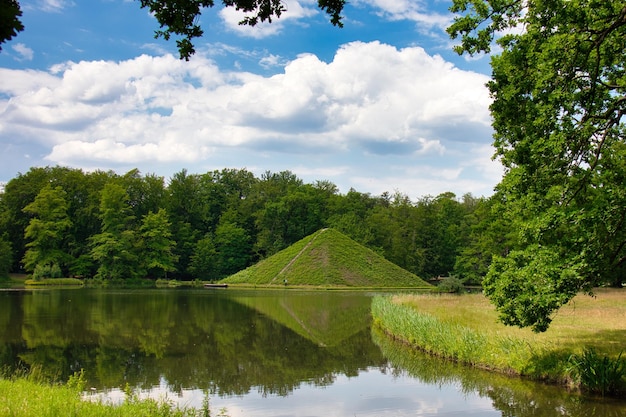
[0,290,385,395]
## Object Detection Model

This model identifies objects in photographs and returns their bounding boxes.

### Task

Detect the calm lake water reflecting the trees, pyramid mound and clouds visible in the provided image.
[0,289,626,417]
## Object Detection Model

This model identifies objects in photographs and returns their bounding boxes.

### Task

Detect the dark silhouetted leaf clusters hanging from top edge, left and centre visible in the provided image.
[0,0,346,60]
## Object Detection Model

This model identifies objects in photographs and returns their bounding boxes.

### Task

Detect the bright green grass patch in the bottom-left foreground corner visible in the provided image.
[0,370,218,417]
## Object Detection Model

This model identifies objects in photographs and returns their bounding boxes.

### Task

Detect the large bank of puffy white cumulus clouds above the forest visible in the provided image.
[0,42,497,195]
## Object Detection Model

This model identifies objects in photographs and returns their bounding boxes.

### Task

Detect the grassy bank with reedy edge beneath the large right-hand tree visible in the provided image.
[372,290,626,396]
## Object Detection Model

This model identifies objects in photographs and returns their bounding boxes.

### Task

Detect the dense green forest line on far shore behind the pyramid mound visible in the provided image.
[0,166,512,284]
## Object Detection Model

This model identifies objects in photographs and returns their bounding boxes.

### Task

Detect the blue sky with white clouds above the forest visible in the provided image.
[0,0,503,200]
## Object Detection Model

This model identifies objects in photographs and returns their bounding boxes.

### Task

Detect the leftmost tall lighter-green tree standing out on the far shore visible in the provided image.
[23,184,72,277]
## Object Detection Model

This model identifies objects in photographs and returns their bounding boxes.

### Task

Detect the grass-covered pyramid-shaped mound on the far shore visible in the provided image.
[221,229,430,288]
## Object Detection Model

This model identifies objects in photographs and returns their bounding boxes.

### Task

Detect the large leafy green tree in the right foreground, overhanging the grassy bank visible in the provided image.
[448,0,626,331]
